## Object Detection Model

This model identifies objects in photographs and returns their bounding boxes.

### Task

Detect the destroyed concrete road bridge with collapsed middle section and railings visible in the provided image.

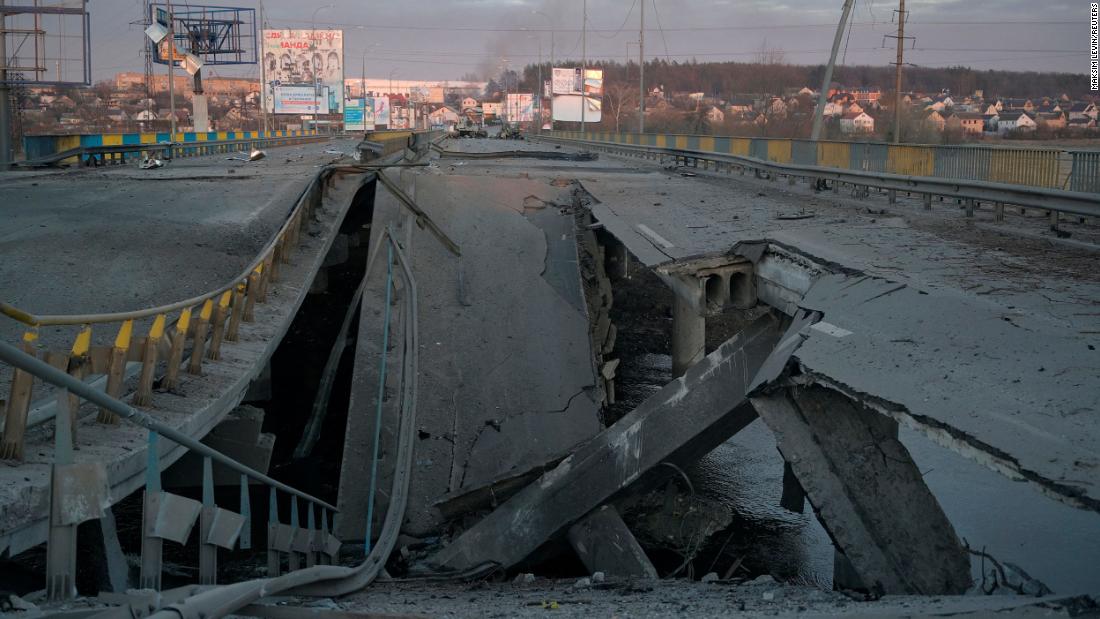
[0,132,1100,618]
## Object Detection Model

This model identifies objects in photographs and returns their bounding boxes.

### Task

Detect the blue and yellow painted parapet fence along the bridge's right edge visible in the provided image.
[550,131,1078,191]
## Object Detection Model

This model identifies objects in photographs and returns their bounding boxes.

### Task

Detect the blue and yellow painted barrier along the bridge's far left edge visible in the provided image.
[15,135,329,167]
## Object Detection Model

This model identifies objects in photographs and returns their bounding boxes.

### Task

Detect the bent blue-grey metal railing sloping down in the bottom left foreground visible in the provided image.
[0,342,340,601]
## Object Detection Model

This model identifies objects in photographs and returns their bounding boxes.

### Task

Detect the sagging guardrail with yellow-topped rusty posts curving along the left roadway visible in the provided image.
[0,164,331,461]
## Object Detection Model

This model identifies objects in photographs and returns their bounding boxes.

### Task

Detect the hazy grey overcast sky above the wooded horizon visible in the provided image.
[88,0,1089,79]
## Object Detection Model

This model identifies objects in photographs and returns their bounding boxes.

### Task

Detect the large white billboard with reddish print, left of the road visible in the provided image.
[263,30,344,114]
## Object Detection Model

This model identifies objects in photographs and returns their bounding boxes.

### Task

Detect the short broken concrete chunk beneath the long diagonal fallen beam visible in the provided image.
[569,505,657,578]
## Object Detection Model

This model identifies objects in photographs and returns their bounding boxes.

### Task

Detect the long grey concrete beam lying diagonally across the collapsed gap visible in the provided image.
[428,313,807,570]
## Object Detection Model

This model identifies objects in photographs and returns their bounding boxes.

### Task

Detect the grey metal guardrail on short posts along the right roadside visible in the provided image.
[540,137,1100,224]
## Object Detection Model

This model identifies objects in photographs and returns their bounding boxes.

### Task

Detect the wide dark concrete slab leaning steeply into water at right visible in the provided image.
[751,386,970,595]
